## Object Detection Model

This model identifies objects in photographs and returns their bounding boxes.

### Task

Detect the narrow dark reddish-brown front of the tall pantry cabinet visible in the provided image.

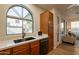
[48,13,54,51]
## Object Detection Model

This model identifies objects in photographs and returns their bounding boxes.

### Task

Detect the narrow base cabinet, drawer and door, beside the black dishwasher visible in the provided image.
[30,40,40,55]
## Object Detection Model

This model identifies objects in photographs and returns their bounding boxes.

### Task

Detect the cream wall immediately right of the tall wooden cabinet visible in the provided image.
[50,8,63,49]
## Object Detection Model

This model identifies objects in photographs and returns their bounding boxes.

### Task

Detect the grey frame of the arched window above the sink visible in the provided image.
[6,4,34,35]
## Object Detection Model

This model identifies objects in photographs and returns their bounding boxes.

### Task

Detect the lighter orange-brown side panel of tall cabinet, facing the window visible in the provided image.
[40,11,49,34]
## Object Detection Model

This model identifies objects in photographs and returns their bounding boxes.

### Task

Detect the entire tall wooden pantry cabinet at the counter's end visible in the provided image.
[40,11,54,51]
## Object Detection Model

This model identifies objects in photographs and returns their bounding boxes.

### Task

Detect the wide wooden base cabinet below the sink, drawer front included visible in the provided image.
[13,43,30,55]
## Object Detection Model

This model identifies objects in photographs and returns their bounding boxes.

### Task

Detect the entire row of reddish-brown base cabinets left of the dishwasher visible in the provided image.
[0,40,40,55]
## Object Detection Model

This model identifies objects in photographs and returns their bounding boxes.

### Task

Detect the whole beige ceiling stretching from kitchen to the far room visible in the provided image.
[36,4,79,20]
